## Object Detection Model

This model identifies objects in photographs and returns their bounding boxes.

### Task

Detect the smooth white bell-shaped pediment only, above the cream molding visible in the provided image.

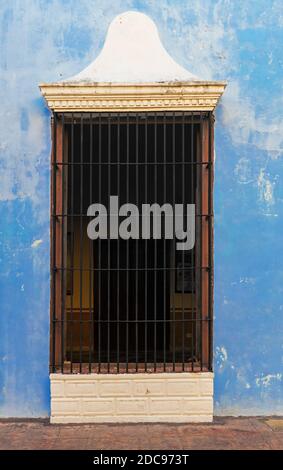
[64,11,200,83]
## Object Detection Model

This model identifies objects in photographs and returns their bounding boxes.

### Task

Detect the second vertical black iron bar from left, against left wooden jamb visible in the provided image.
[61,113,66,374]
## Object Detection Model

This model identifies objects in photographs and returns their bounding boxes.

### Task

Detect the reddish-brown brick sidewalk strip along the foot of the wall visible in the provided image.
[0,418,283,450]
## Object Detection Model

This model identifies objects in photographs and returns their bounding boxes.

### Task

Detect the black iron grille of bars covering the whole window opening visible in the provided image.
[50,111,213,373]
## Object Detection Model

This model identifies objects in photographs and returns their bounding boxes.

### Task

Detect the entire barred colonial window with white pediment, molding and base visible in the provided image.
[40,12,225,422]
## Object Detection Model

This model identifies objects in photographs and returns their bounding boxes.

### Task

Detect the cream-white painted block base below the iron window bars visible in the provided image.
[50,372,213,423]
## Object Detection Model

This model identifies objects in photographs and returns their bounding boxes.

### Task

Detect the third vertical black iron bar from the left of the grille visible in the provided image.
[70,113,75,373]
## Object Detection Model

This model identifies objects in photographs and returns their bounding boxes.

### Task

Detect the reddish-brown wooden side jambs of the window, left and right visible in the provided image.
[50,112,214,372]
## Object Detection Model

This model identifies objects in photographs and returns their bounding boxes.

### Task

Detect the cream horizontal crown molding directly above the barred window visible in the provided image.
[39,81,226,112]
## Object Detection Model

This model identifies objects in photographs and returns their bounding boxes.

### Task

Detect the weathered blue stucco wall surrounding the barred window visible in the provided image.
[0,0,283,417]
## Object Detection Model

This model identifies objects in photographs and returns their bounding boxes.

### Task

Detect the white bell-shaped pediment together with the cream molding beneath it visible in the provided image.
[40,11,226,112]
